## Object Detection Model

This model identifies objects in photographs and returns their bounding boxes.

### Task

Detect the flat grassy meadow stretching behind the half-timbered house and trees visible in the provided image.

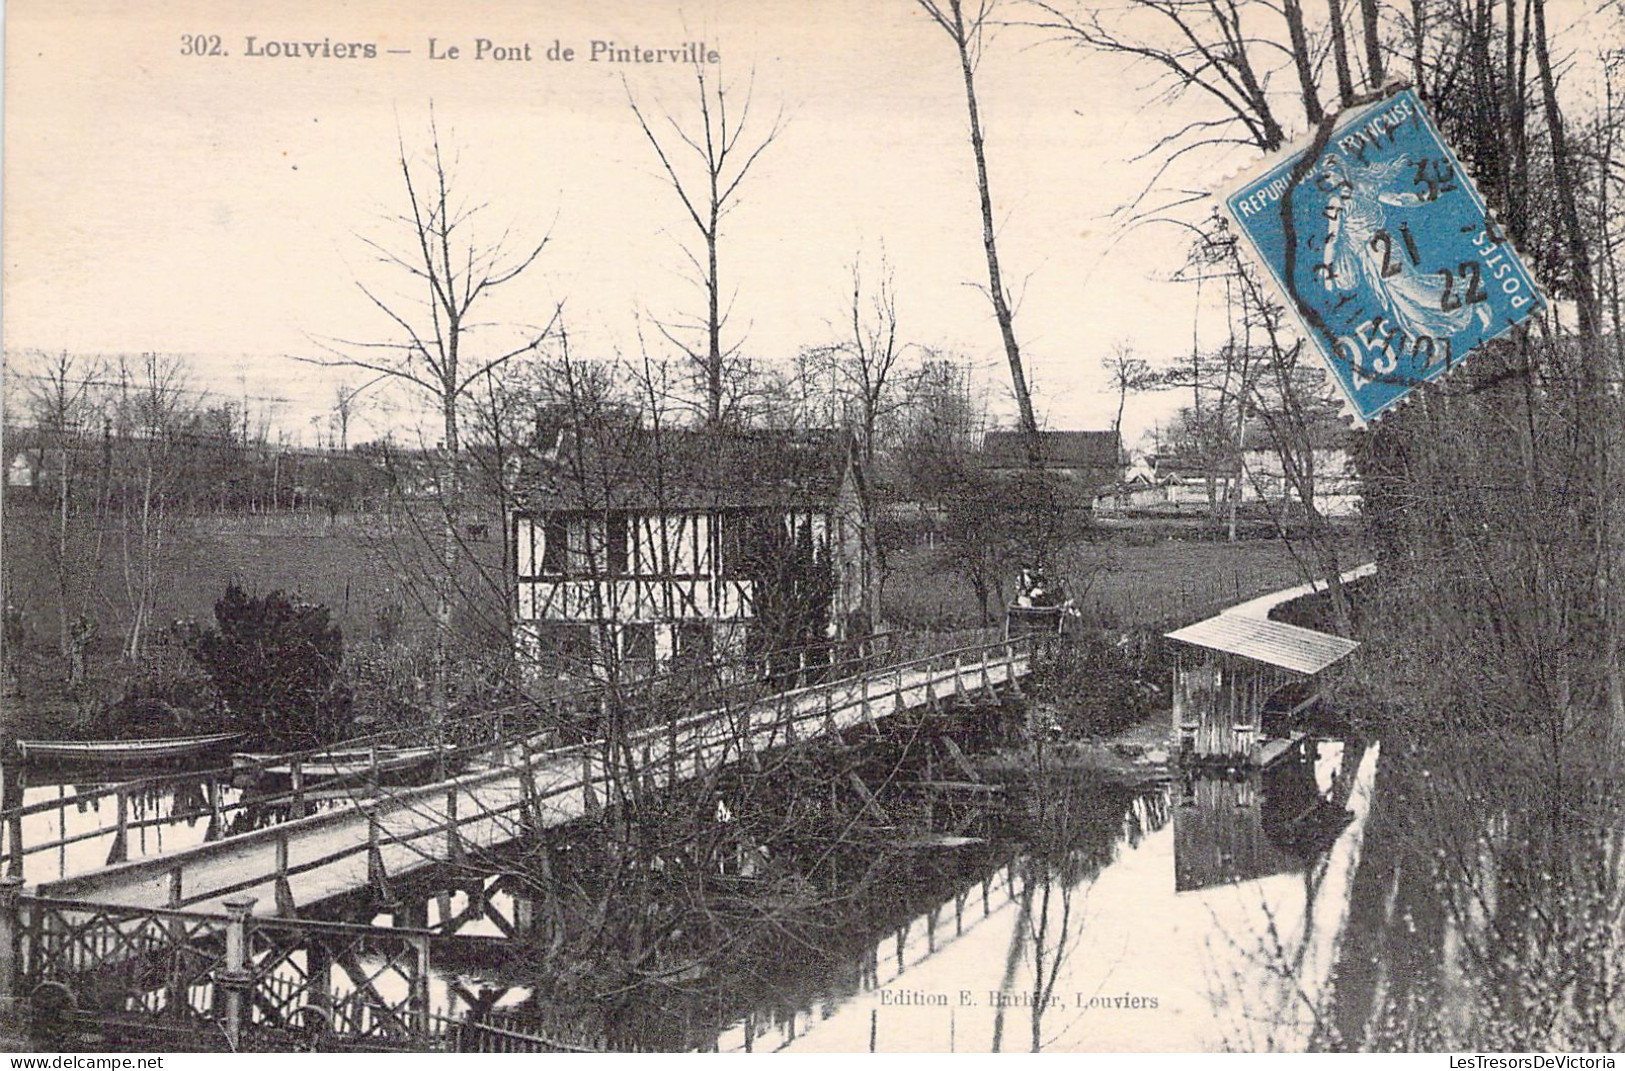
[3,499,1355,737]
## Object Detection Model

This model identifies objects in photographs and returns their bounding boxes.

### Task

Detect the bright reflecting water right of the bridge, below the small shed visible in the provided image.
[717,744,1376,1051]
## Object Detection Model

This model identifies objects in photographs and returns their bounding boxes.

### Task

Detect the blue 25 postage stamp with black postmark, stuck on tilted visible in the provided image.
[1224,89,1545,424]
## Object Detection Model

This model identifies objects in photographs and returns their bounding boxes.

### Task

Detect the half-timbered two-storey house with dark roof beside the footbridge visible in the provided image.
[507,423,871,676]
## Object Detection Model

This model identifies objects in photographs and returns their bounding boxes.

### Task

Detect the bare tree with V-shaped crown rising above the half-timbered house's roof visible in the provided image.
[627,65,783,424]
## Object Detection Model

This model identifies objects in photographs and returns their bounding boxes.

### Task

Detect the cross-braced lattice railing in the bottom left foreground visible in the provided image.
[0,881,507,1048]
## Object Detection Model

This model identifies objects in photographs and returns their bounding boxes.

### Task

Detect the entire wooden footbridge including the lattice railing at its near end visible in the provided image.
[0,637,1034,1050]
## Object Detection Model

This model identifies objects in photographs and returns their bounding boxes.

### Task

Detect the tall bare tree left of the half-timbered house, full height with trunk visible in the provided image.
[322,111,559,728]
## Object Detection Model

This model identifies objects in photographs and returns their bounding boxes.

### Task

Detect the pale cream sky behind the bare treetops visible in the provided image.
[3,0,1618,440]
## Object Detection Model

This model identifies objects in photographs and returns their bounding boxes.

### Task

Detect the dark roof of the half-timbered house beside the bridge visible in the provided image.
[517,424,852,510]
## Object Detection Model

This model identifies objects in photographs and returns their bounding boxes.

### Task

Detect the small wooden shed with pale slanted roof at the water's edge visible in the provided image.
[1167,614,1359,765]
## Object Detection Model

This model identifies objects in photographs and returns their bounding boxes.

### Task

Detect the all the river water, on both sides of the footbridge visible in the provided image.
[0,741,1376,1051]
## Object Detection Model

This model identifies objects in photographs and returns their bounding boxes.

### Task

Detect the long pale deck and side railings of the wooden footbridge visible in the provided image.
[38,639,1032,908]
